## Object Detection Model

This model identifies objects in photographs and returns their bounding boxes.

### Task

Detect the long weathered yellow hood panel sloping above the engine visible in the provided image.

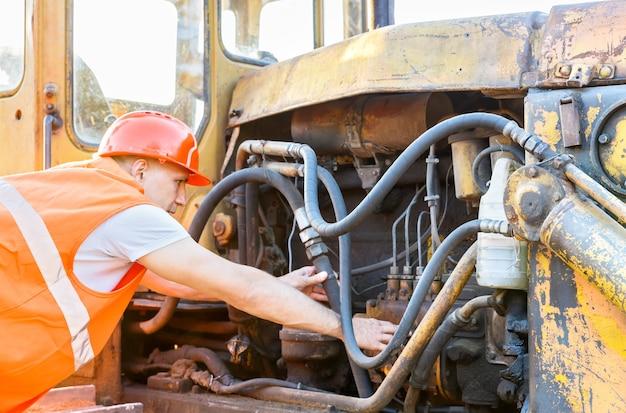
[229,13,545,126]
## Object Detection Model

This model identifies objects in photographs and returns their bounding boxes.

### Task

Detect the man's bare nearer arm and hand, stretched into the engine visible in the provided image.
[138,238,395,350]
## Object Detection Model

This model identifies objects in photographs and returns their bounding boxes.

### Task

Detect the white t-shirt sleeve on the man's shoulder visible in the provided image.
[74,205,189,292]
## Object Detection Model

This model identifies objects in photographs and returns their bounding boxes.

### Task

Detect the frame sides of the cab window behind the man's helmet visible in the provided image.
[65,0,212,152]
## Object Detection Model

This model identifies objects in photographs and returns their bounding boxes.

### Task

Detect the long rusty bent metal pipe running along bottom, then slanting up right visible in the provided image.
[248,240,476,412]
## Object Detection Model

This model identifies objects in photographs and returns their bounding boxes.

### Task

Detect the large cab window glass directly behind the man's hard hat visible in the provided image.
[72,0,208,146]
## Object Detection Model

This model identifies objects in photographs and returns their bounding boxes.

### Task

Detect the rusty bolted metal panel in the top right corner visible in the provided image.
[539,1,626,87]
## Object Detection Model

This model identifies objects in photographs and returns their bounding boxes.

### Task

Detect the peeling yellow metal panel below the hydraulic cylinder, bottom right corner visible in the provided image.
[529,247,626,412]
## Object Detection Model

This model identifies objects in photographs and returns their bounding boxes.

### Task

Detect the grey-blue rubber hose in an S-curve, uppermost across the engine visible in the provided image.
[299,113,510,237]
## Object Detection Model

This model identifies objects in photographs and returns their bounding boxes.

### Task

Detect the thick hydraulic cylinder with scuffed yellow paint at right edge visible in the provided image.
[540,194,626,311]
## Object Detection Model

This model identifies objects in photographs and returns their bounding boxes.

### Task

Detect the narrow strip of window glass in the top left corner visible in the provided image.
[0,0,25,93]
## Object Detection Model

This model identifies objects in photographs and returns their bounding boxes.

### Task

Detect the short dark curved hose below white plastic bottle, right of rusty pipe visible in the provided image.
[410,295,494,390]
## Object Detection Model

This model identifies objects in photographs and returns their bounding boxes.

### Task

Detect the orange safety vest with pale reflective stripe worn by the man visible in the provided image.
[0,158,150,412]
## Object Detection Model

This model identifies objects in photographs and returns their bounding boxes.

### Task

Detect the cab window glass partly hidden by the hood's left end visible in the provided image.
[220,0,314,64]
